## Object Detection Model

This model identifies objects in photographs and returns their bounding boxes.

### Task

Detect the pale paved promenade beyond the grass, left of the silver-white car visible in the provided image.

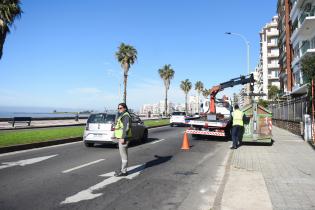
[0,119,87,130]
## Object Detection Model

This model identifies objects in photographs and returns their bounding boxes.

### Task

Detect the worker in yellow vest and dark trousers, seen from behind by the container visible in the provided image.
[231,104,244,149]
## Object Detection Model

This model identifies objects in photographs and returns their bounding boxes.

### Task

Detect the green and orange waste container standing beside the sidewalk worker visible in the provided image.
[242,103,272,143]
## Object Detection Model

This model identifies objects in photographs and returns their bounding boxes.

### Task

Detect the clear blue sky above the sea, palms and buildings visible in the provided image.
[0,0,277,110]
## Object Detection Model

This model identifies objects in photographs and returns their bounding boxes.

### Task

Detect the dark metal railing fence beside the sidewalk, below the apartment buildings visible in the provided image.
[269,97,309,122]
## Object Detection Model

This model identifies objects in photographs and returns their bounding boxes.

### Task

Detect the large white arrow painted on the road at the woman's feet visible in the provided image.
[60,164,145,204]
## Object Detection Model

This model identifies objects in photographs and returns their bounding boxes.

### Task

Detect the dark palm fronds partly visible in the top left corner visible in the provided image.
[0,0,22,59]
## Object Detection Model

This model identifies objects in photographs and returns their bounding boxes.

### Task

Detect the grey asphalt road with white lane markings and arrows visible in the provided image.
[0,127,230,210]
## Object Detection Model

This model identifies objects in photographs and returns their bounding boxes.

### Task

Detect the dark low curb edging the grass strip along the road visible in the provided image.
[0,124,169,154]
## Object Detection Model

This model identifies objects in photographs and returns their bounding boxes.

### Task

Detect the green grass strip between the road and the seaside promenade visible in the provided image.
[0,119,169,147]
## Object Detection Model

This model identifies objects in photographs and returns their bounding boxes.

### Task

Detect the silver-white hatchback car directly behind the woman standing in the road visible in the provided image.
[83,113,148,147]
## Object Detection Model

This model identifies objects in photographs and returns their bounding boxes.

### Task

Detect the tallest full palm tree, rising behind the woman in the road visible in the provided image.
[116,43,137,103]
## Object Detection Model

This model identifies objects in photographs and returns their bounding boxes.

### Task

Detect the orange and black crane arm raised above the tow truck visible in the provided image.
[209,74,255,114]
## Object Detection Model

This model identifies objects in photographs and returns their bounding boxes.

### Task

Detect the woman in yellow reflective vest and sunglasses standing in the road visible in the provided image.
[114,103,132,176]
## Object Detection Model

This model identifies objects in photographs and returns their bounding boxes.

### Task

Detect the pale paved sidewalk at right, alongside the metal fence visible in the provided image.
[218,126,315,210]
